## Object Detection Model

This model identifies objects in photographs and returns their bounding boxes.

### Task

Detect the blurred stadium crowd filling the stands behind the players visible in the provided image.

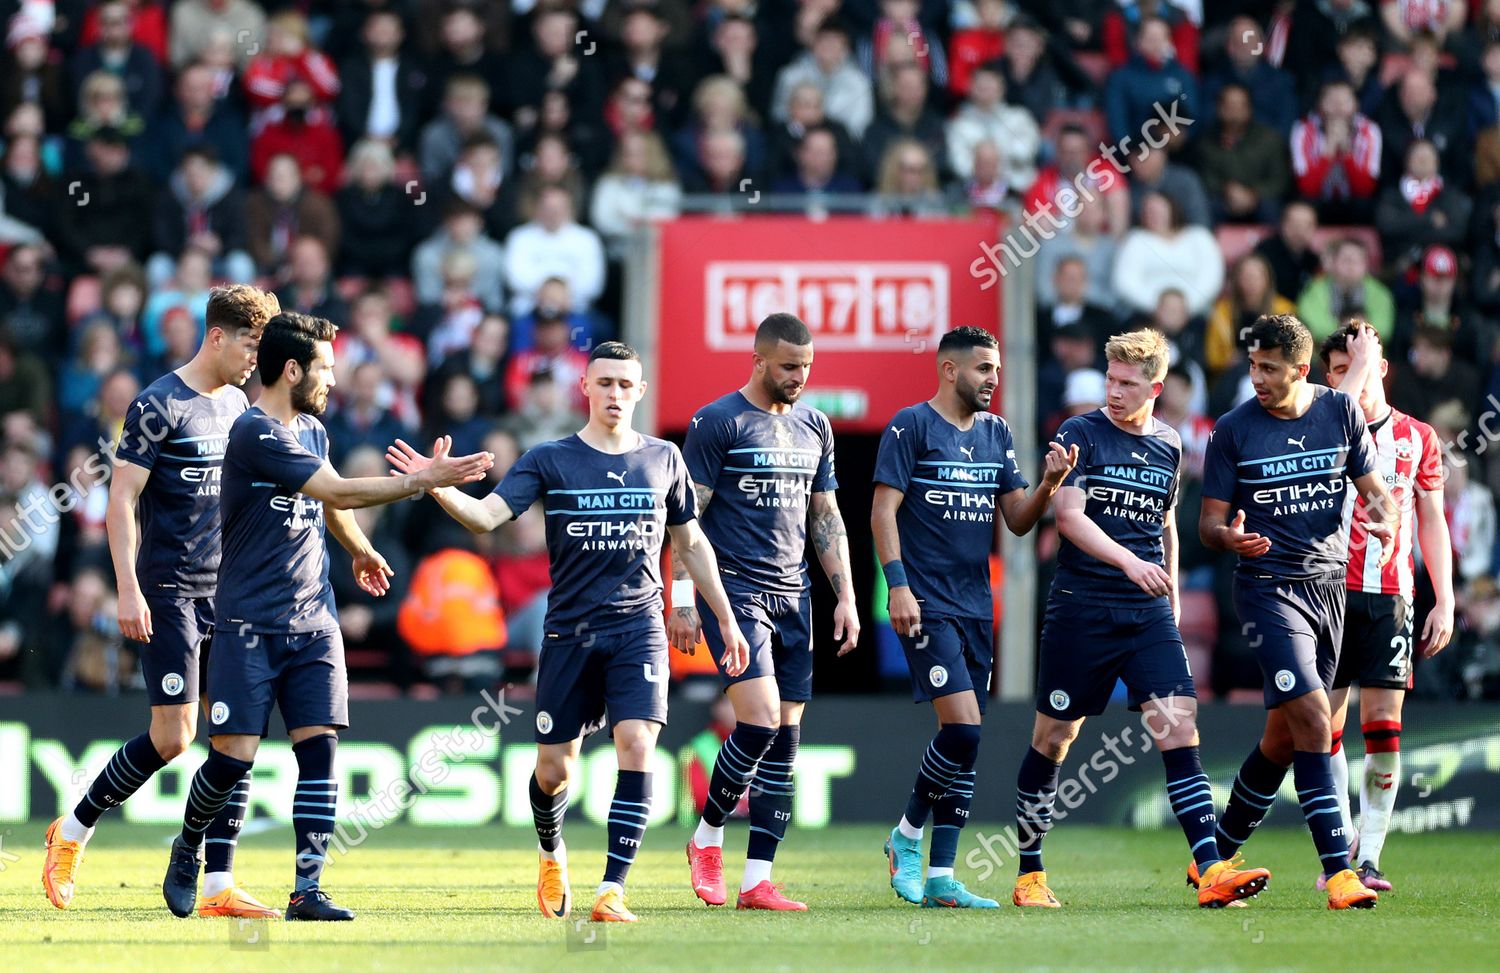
[0,0,1500,699]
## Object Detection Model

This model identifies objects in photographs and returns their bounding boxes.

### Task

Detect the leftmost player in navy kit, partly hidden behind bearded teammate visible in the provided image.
[42,285,281,918]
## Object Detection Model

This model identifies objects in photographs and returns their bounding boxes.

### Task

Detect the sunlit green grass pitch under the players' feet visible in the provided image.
[0,820,1500,973]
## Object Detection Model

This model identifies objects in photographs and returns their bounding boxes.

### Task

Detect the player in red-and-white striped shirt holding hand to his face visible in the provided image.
[1320,321,1454,891]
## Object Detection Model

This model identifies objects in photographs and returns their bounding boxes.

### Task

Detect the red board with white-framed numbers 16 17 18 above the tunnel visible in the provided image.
[653,216,1004,432]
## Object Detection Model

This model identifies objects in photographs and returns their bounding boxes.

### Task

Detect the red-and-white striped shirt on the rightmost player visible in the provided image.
[1344,409,1443,601]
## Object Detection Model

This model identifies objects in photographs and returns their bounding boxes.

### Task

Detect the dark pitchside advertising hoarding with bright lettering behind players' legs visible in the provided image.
[0,694,1500,831]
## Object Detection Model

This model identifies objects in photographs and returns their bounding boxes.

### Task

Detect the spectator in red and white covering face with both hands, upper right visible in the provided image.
[1292,81,1382,223]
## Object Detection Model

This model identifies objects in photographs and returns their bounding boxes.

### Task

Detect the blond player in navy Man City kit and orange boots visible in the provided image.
[1011,330,1271,909]
